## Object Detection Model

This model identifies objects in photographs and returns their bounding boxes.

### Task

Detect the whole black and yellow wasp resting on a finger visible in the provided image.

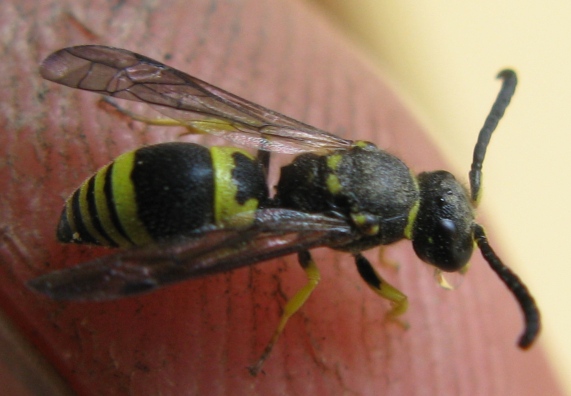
[29,46,540,374]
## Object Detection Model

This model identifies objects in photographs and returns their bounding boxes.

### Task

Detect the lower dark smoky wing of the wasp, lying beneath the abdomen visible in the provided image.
[28,209,353,300]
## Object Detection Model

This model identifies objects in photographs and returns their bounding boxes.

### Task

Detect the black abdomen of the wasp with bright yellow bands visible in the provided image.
[58,143,268,246]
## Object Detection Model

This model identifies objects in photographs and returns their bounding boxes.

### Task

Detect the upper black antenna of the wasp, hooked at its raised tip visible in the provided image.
[470,69,517,204]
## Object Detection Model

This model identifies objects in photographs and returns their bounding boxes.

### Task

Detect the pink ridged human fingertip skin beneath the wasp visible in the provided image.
[0,0,561,395]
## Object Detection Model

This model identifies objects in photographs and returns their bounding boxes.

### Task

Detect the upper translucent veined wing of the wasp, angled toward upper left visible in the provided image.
[40,45,352,154]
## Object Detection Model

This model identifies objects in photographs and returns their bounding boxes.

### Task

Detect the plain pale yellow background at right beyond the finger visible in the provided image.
[314,0,571,394]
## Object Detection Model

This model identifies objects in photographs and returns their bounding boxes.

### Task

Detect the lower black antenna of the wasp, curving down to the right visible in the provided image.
[474,224,541,349]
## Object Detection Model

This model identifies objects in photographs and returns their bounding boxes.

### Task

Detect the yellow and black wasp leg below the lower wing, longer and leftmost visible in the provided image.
[248,251,321,376]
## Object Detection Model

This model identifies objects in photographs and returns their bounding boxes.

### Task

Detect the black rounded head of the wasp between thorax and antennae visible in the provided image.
[412,171,474,272]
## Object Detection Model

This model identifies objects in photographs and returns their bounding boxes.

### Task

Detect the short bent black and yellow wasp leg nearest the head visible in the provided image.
[355,254,408,328]
